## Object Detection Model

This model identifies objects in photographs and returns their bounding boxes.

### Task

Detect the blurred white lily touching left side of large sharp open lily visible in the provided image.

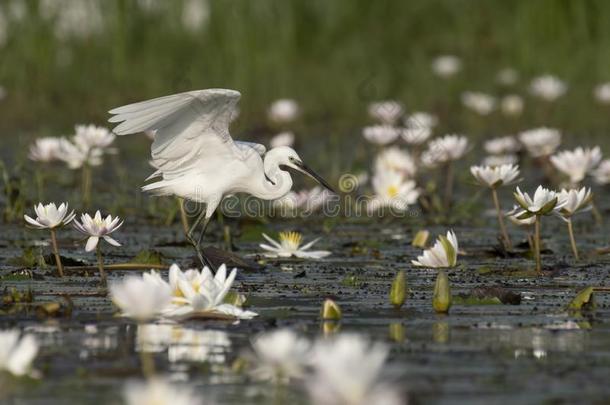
[109,270,172,321]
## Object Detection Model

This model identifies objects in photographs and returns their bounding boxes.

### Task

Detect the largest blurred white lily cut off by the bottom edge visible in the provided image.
[306,334,405,405]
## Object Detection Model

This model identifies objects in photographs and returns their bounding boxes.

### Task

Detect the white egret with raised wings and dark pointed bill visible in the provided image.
[109,89,332,267]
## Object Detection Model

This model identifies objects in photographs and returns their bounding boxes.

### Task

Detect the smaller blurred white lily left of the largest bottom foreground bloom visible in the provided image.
[252,329,311,382]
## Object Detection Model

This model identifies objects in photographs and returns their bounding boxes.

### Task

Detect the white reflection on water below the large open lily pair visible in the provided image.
[136,324,231,364]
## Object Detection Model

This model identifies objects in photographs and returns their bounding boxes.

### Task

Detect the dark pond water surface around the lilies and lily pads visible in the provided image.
[0,200,610,404]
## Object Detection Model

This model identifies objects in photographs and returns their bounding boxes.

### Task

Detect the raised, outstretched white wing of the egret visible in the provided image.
[109,89,244,179]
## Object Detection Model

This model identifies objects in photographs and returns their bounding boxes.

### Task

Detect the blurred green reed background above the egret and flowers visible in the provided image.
[0,0,610,141]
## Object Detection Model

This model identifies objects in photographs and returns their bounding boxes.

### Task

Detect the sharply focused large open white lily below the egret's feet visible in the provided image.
[164,264,258,319]
